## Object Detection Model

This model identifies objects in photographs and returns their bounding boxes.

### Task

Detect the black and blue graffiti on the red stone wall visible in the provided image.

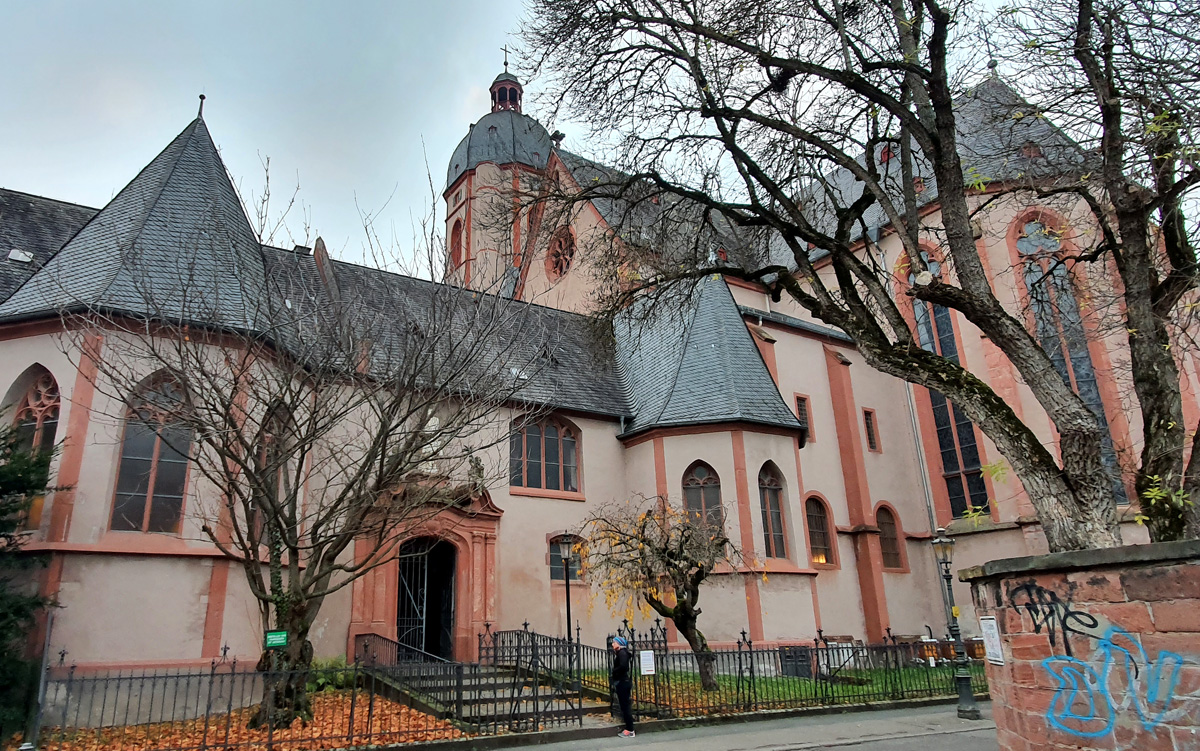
[1009,583,1184,738]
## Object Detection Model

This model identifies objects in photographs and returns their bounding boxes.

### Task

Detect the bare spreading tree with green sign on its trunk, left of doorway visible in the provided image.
[51,200,557,726]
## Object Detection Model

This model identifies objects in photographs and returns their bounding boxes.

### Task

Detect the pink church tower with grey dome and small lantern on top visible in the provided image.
[443,65,554,294]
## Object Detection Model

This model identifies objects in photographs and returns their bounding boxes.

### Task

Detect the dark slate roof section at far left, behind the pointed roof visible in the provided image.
[0,188,96,300]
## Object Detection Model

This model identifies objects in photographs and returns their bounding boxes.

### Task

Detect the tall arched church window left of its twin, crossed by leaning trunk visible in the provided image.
[908,252,988,518]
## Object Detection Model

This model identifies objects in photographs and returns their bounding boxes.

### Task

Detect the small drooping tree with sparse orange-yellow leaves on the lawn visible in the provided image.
[578,498,740,691]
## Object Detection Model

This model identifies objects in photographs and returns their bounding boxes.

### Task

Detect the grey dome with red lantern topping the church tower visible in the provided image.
[446,64,553,190]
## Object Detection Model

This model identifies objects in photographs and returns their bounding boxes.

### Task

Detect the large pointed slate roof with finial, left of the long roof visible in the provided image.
[0,118,265,328]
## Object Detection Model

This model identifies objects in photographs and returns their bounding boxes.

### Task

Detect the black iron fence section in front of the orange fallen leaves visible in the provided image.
[22,661,468,751]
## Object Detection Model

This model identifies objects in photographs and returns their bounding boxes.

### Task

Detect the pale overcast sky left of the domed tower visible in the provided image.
[0,0,561,260]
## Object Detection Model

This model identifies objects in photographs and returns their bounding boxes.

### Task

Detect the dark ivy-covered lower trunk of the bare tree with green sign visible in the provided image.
[246,608,312,729]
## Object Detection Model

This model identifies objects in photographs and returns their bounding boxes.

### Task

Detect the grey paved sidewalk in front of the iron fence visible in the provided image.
[516,702,998,751]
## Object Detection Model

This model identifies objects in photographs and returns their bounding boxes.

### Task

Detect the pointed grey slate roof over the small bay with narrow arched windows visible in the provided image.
[616,273,802,435]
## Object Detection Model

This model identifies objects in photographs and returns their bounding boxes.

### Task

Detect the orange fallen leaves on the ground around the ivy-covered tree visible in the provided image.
[14,691,464,751]
